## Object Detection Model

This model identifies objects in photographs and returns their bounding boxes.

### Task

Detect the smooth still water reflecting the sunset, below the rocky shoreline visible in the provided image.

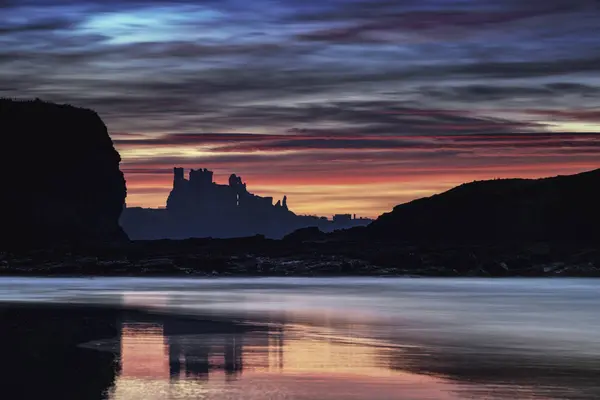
[0,278,600,400]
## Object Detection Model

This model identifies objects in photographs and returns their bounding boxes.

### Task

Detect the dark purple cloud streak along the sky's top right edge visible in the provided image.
[292,0,597,43]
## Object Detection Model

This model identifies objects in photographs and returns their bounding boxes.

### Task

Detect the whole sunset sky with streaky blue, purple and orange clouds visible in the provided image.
[0,0,600,217]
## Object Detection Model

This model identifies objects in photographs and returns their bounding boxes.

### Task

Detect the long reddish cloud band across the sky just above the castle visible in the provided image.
[114,125,600,155]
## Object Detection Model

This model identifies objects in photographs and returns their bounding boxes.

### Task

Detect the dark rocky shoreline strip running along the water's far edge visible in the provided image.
[0,236,600,277]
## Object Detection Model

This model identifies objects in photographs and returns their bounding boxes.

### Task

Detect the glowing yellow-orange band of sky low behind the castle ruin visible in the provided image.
[120,160,592,218]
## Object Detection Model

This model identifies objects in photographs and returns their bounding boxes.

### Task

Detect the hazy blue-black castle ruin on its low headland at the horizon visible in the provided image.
[120,168,371,239]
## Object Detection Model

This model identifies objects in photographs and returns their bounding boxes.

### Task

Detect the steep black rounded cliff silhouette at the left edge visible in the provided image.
[0,99,127,248]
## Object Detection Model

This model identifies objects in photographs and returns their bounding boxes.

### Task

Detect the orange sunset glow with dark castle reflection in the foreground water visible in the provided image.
[110,319,460,400]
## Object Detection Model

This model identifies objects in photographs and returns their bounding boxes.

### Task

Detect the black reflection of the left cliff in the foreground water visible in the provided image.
[0,304,119,400]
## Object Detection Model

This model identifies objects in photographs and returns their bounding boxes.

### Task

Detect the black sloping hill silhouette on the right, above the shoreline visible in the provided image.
[361,169,600,242]
